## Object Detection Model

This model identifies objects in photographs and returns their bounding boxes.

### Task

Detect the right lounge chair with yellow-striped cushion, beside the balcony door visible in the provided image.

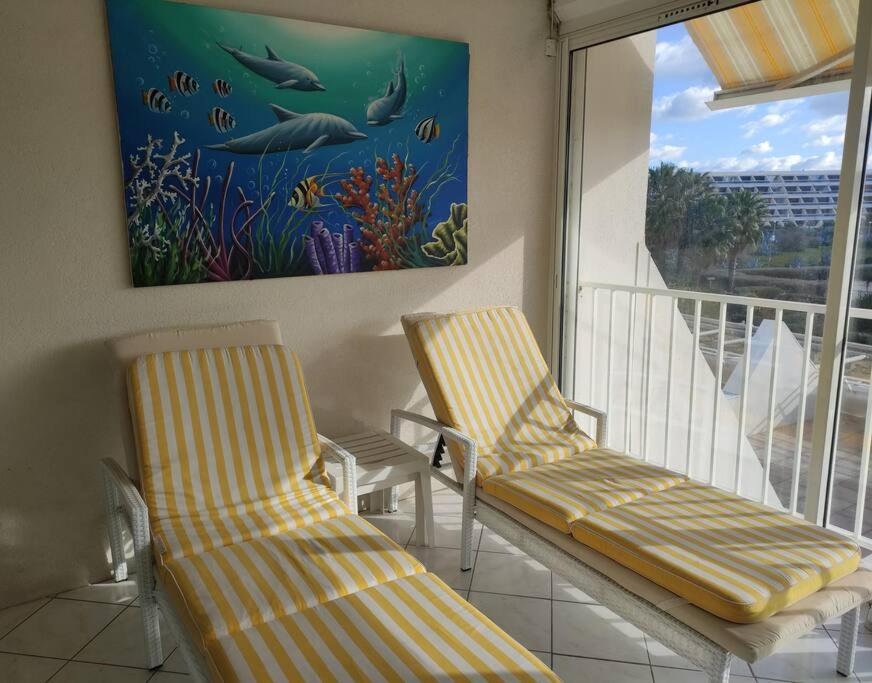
[391,307,872,683]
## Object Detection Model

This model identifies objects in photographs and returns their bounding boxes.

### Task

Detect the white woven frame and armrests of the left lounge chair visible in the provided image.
[101,434,357,683]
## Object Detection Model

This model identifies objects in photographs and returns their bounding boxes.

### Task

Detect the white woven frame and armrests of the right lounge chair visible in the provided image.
[391,398,860,683]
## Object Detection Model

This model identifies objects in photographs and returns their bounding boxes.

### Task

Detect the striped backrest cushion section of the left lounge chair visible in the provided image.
[128,346,327,519]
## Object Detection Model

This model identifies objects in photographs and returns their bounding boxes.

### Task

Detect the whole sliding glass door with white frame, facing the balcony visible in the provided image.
[554,0,872,547]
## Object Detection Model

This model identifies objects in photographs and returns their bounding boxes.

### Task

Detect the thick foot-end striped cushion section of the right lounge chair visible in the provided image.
[572,482,860,623]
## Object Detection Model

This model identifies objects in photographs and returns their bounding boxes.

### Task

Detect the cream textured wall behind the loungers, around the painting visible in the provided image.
[0,0,555,607]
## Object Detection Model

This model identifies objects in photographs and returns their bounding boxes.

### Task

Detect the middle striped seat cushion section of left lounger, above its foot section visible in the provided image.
[162,514,425,640]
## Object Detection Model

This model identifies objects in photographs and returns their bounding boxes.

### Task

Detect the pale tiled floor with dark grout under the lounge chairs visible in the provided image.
[0,482,872,683]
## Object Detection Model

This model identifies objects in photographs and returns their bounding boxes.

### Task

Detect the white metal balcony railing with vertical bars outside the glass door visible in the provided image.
[575,282,872,548]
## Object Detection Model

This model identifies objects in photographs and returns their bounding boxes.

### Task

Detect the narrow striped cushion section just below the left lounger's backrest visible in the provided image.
[151,483,350,561]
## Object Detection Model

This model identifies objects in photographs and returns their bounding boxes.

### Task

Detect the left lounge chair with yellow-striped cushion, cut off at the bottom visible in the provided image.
[103,322,557,681]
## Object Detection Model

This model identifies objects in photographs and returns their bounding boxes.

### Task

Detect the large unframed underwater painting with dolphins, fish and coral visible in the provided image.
[107,0,469,287]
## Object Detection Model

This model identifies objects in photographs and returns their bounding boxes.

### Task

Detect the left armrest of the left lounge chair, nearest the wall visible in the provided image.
[100,458,154,599]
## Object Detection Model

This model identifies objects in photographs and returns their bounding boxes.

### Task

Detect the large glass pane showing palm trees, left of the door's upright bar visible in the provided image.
[575,0,856,512]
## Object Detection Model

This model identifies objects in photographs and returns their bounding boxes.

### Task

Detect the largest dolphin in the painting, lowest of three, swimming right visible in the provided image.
[208,104,367,154]
